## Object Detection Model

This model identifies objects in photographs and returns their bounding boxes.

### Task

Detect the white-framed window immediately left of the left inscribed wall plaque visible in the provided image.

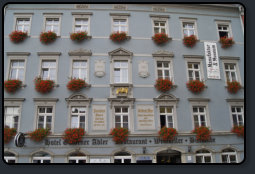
[71,107,86,129]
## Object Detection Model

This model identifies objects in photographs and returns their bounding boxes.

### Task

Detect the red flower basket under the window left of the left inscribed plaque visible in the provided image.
[63,128,86,144]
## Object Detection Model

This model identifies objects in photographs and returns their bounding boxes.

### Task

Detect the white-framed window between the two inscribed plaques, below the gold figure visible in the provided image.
[114,107,129,129]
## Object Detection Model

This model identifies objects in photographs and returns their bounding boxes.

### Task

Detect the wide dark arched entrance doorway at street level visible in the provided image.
[157,150,181,164]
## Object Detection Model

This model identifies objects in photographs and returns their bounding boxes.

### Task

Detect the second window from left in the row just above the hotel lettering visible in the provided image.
[37,106,53,129]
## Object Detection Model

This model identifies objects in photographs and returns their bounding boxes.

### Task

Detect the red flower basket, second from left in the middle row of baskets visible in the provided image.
[35,77,54,94]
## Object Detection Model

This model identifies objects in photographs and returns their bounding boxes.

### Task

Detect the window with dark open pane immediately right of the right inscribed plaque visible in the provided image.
[159,106,174,128]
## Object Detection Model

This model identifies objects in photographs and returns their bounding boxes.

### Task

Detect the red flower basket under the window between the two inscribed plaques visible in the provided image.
[110,128,129,144]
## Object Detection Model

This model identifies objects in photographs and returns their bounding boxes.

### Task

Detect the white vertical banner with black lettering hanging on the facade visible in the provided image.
[204,42,220,79]
